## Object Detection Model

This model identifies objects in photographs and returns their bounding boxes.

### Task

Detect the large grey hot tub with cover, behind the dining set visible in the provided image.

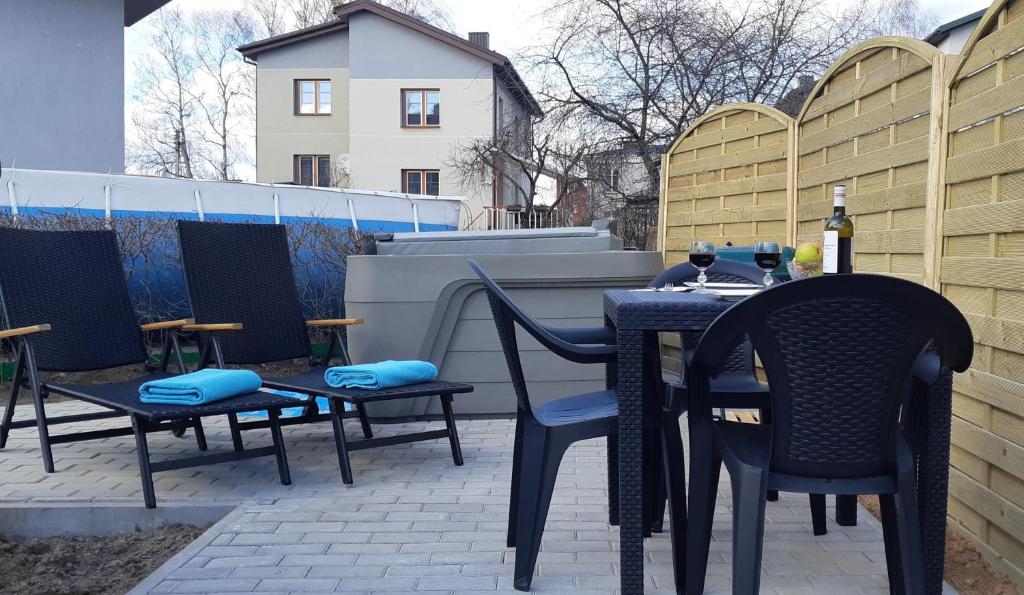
[345,227,664,418]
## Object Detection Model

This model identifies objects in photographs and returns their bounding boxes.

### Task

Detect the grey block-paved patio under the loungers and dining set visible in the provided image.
[0,396,951,595]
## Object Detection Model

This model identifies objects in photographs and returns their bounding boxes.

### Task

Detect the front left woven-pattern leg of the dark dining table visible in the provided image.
[616,330,645,595]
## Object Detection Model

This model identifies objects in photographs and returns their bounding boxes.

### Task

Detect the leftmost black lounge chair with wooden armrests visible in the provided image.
[0,227,294,508]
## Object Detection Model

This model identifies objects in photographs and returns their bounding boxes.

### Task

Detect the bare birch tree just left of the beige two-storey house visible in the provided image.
[193,10,255,180]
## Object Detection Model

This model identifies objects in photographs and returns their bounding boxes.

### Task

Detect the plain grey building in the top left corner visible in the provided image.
[0,0,169,172]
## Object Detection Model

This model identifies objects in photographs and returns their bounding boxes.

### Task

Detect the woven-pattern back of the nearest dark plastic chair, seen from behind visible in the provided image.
[693,274,974,478]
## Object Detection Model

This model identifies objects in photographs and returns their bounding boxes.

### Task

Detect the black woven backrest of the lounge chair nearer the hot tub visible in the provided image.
[178,221,310,364]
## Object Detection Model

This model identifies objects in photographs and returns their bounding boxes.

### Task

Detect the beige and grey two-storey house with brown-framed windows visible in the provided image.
[239,0,540,223]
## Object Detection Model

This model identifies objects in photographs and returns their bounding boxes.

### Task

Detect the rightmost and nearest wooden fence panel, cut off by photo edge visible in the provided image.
[939,0,1024,584]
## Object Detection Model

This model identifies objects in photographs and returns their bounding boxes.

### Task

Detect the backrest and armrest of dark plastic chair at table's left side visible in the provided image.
[469,260,607,415]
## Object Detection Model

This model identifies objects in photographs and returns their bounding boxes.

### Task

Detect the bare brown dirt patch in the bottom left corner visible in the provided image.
[0,525,206,595]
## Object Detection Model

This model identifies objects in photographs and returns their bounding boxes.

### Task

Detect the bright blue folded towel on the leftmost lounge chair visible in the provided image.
[138,368,262,406]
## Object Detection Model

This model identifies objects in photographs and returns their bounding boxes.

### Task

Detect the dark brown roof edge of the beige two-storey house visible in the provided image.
[239,0,543,116]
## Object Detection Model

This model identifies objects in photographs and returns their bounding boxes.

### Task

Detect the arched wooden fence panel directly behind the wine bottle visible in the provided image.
[791,38,941,283]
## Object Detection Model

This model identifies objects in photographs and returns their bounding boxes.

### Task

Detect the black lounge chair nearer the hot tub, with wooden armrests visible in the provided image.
[178,221,473,484]
